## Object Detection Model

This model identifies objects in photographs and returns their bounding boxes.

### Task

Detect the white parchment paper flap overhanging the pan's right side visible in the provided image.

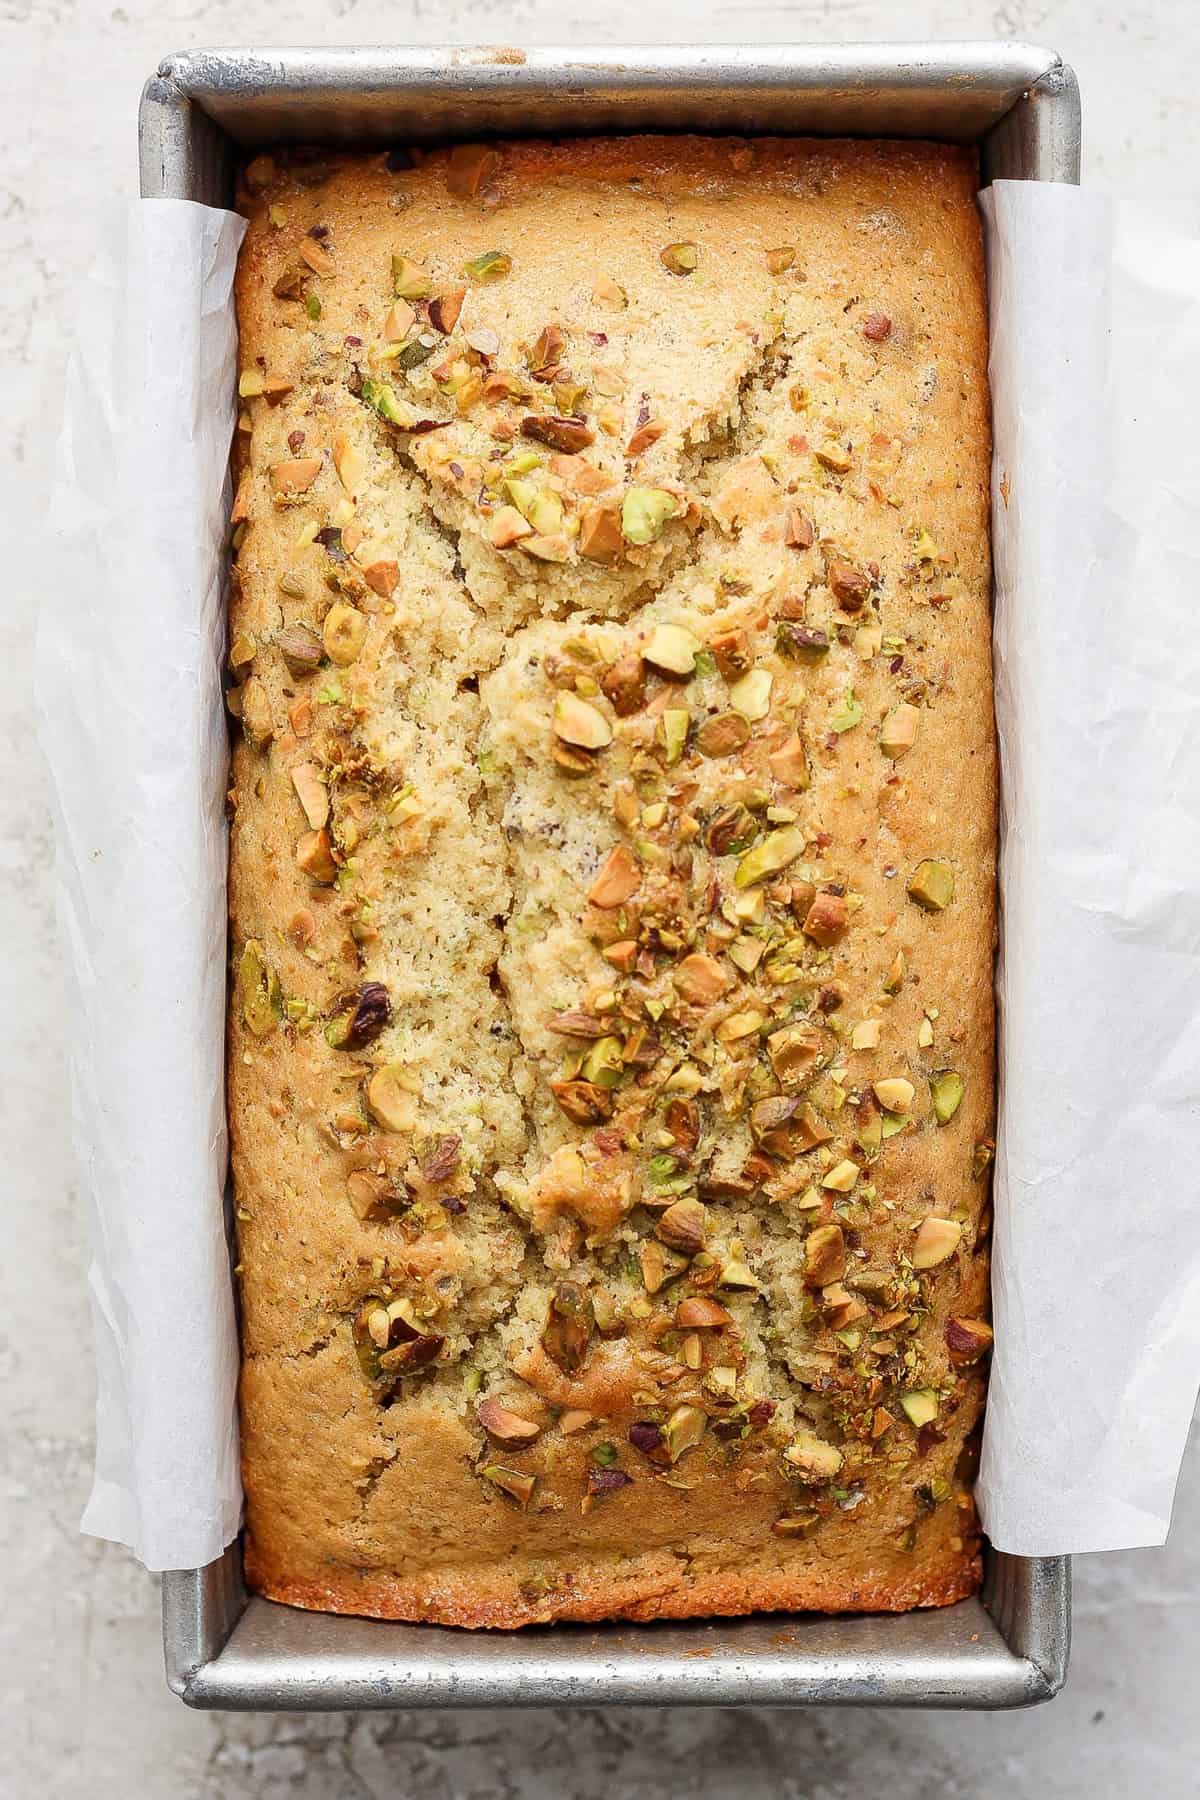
[979,182,1200,1555]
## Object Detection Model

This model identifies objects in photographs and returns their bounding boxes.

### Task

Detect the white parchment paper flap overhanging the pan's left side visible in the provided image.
[38,200,245,1570]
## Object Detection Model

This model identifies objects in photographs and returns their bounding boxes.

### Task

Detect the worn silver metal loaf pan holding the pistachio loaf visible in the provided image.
[139,43,1079,1710]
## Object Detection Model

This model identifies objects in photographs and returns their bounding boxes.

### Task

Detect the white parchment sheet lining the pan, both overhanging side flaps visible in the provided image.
[40,182,1200,1568]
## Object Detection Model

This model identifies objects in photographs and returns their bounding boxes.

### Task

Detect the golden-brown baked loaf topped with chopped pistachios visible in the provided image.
[228,139,995,1625]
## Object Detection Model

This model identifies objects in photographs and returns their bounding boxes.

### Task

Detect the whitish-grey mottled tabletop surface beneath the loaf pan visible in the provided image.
[0,0,1200,1800]
